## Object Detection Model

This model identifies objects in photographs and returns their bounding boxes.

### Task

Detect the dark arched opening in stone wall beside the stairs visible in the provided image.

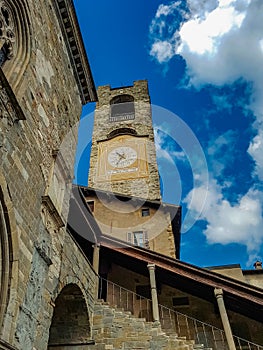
[48,284,91,350]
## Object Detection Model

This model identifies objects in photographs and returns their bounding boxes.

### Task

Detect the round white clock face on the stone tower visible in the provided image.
[108,146,137,168]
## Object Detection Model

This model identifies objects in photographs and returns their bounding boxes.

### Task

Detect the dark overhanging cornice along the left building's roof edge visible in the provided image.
[55,0,97,104]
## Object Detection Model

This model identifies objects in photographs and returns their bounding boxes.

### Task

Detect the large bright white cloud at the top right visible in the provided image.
[150,0,263,104]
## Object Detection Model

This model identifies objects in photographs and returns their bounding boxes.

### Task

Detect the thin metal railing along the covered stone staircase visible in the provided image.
[99,277,263,350]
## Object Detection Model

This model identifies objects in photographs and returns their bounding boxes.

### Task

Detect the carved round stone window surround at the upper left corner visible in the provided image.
[0,0,31,90]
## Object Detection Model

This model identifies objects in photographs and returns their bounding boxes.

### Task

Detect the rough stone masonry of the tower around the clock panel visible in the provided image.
[88,80,160,200]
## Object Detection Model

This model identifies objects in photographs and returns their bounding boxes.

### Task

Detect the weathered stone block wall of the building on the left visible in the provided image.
[0,0,95,350]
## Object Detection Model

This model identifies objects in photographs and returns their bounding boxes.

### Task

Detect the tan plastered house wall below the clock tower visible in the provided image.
[87,193,176,257]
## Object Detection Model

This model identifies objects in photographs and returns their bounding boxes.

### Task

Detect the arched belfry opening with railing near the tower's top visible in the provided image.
[110,94,135,122]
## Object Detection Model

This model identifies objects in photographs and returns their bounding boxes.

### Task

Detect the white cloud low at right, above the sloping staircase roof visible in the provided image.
[185,180,263,258]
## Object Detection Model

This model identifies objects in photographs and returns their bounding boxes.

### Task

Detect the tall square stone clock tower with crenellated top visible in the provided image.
[88,80,161,200]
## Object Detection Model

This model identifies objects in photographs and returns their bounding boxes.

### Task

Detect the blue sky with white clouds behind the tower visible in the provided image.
[74,0,263,268]
